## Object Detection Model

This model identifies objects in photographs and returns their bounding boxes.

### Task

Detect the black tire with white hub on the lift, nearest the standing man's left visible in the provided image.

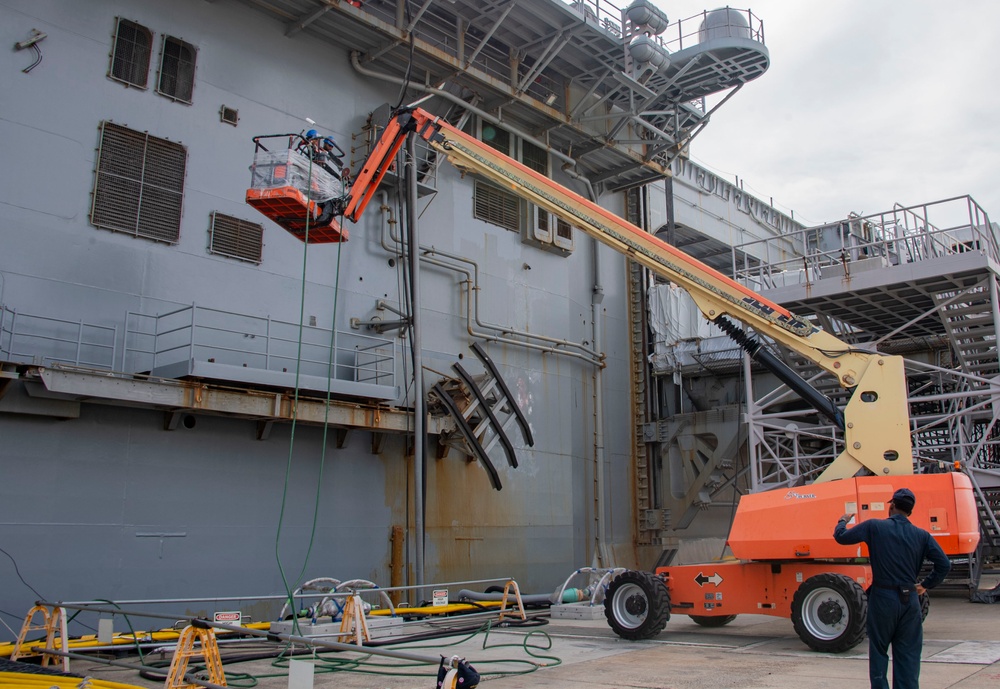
[792,574,868,653]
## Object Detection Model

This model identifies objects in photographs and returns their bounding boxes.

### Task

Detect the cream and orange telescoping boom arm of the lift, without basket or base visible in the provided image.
[344,108,913,481]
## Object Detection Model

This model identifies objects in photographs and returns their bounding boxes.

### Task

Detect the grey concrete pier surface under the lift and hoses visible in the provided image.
[43,580,1000,689]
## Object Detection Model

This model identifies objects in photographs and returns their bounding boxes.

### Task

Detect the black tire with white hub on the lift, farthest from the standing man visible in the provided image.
[604,570,670,641]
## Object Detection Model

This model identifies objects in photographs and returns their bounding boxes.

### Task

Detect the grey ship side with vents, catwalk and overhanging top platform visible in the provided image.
[0,1,768,628]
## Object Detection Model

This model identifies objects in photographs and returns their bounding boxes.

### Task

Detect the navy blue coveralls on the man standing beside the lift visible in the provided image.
[833,513,951,689]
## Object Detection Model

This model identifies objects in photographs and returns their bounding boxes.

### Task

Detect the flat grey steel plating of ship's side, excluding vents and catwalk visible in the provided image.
[0,0,636,626]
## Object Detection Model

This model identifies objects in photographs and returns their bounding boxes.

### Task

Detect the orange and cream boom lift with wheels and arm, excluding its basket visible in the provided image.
[252,108,979,652]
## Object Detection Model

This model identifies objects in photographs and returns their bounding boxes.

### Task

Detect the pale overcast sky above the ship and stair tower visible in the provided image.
[656,0,1000,224]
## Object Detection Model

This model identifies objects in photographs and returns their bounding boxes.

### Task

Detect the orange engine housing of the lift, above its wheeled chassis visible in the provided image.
[729,472,979,560]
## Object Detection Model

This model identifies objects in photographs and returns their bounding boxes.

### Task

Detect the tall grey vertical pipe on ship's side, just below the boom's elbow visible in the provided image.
[405,132,427,598]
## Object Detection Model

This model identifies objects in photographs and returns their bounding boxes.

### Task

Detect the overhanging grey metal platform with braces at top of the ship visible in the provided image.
[230,0,770,190]
